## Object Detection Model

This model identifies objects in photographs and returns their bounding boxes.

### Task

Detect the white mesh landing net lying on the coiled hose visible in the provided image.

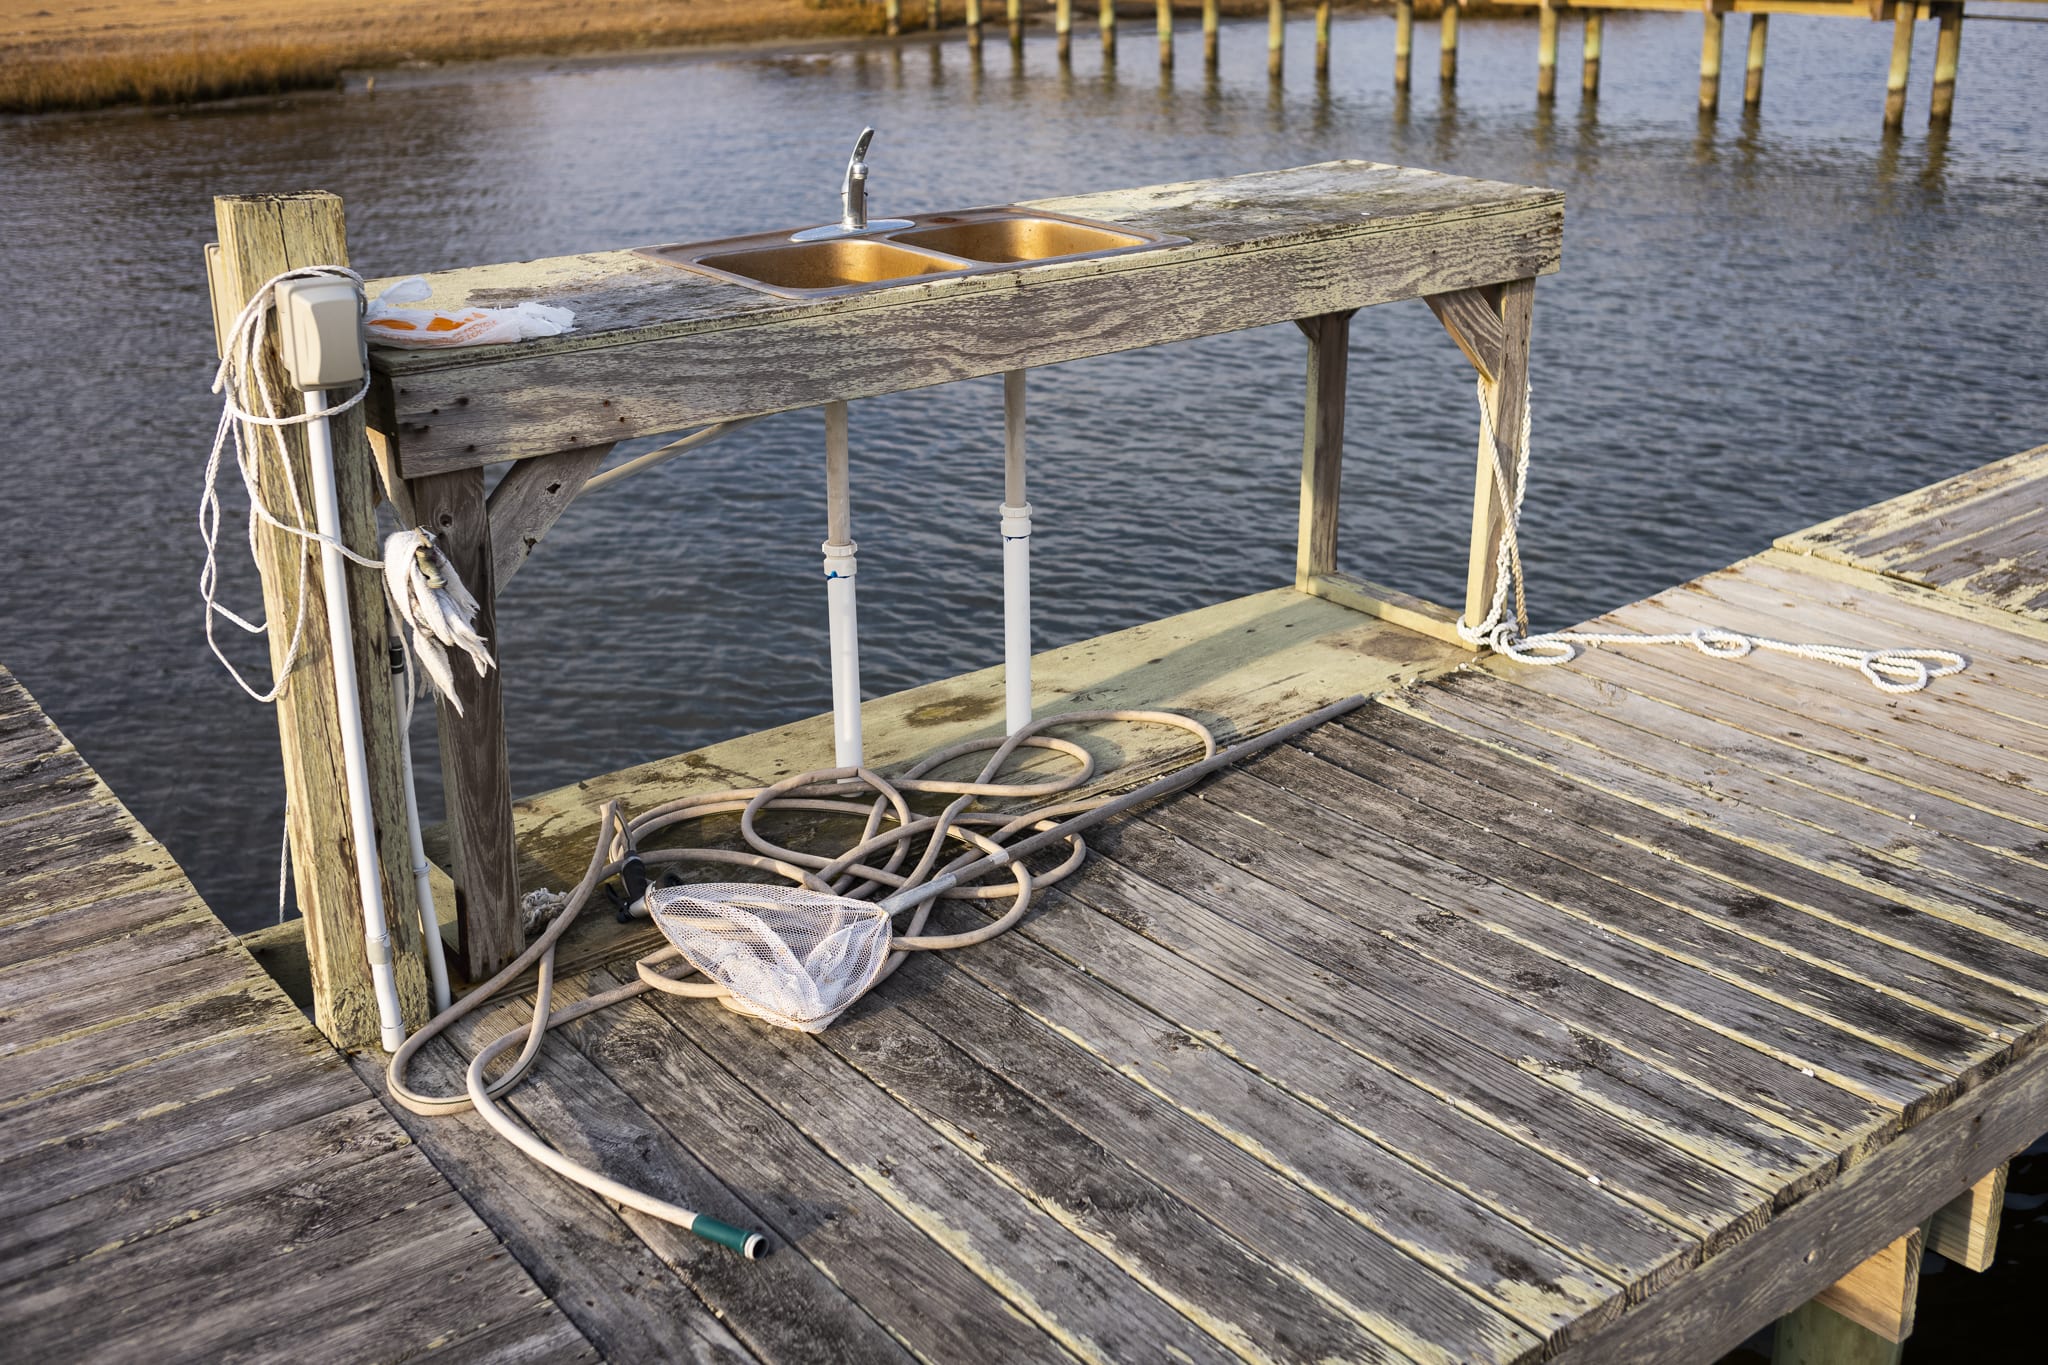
[647,884,891,1033]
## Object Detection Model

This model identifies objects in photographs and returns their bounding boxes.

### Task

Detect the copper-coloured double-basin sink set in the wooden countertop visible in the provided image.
[637,207,1186,299]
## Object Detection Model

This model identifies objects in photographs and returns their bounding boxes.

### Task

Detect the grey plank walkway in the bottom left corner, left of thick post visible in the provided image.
[0,667,593,1361]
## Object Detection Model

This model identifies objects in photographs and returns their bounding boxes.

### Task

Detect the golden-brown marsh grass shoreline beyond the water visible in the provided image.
[0,0,1409,115]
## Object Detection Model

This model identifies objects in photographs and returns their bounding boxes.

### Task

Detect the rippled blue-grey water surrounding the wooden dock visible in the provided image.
[0,14,2048,927]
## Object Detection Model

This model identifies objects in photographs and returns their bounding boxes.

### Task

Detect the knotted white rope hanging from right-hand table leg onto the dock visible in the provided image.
[1458,381,1970,694]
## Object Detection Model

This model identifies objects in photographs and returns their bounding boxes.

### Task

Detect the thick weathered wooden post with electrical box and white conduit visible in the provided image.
[207,194,430,1048]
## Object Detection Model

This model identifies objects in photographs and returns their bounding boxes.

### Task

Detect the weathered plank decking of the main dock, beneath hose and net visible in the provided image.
[372,450,2048,1361]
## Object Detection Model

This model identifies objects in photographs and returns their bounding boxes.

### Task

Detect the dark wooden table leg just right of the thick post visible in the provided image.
[408,469,526,980]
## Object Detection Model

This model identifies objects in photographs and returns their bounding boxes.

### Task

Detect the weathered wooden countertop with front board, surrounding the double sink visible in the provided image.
[373,162,1563,479]
